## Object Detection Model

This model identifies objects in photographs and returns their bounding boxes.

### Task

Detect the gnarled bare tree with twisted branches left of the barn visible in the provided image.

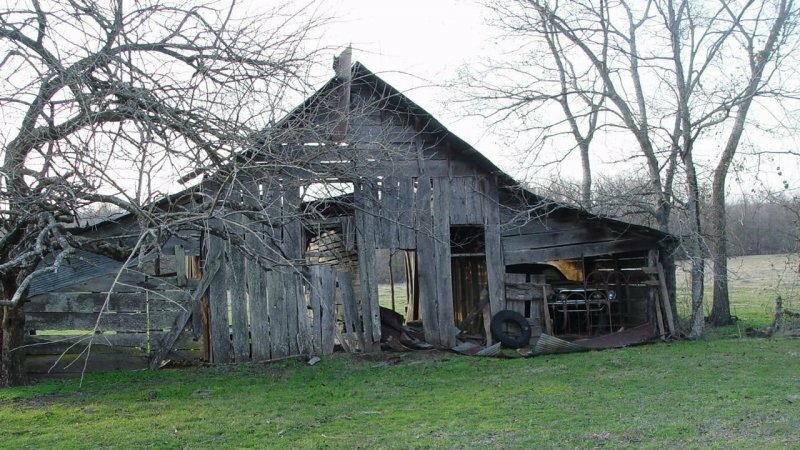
[0,0,320,385]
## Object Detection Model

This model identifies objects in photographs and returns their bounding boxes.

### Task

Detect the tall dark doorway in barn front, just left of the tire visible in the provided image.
[450,225,488,339]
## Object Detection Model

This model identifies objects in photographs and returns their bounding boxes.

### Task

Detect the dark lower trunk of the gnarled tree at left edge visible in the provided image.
[0,298,26,387]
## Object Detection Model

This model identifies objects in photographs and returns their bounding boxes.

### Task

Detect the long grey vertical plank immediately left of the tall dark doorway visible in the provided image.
[432,178,457,348]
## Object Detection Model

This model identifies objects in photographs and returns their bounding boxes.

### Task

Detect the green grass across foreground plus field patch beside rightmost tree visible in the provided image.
[0,253,800,448]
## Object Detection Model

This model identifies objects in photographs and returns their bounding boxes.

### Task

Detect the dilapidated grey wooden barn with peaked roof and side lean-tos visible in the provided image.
[25,54,674,373]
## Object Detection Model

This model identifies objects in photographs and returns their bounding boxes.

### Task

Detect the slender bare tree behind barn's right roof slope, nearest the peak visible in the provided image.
[450,2,608,210]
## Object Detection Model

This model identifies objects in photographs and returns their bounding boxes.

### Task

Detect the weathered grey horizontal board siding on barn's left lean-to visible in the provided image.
[25,270,203,377]
